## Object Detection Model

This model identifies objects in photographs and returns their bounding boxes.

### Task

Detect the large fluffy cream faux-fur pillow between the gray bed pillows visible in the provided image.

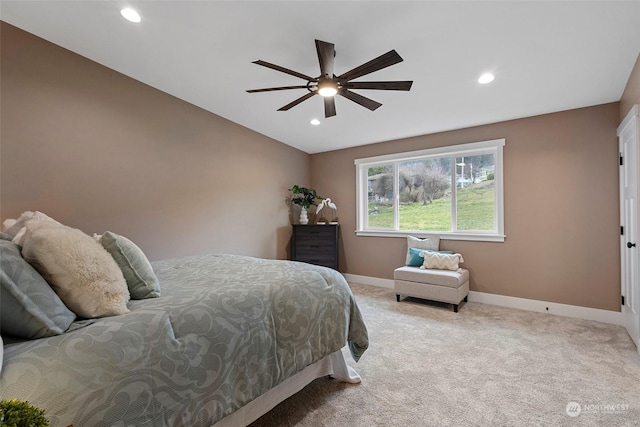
[22,221,129,318]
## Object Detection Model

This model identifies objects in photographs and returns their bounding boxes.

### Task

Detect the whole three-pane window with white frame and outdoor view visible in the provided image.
[355,139,505,242]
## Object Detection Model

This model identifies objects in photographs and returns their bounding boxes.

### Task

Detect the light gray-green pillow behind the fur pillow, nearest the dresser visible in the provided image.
[100,231,160,299]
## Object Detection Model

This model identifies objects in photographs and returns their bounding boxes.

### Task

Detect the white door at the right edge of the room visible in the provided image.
[618,105,640,353]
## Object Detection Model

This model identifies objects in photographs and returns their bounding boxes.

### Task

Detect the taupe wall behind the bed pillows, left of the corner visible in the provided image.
[0,23,310,259]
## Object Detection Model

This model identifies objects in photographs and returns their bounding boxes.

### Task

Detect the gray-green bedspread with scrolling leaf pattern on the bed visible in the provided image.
[0,255,368,427]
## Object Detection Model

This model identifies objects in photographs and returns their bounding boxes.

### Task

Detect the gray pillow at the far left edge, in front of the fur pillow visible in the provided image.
[0,239,76,339]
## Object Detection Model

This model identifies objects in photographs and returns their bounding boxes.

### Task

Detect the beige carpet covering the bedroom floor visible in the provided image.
[251,284,640,427]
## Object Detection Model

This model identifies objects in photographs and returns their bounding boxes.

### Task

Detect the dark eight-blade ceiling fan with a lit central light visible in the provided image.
[247,40,413,117]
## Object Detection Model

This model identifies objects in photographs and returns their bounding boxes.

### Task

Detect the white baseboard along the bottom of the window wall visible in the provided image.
[344,274,622,325]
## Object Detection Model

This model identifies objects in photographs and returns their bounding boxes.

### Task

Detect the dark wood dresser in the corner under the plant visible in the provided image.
[291,224,340,270]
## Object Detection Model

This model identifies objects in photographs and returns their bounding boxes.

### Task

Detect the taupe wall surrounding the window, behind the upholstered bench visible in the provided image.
[311,103,620,311]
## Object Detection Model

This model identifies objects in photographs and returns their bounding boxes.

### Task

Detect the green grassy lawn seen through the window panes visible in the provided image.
[369,181,495,231]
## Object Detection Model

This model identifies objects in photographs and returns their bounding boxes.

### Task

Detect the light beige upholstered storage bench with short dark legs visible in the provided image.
[393,267,469,313]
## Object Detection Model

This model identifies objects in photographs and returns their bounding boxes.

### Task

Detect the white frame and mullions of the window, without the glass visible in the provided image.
[354,138,506,242]
